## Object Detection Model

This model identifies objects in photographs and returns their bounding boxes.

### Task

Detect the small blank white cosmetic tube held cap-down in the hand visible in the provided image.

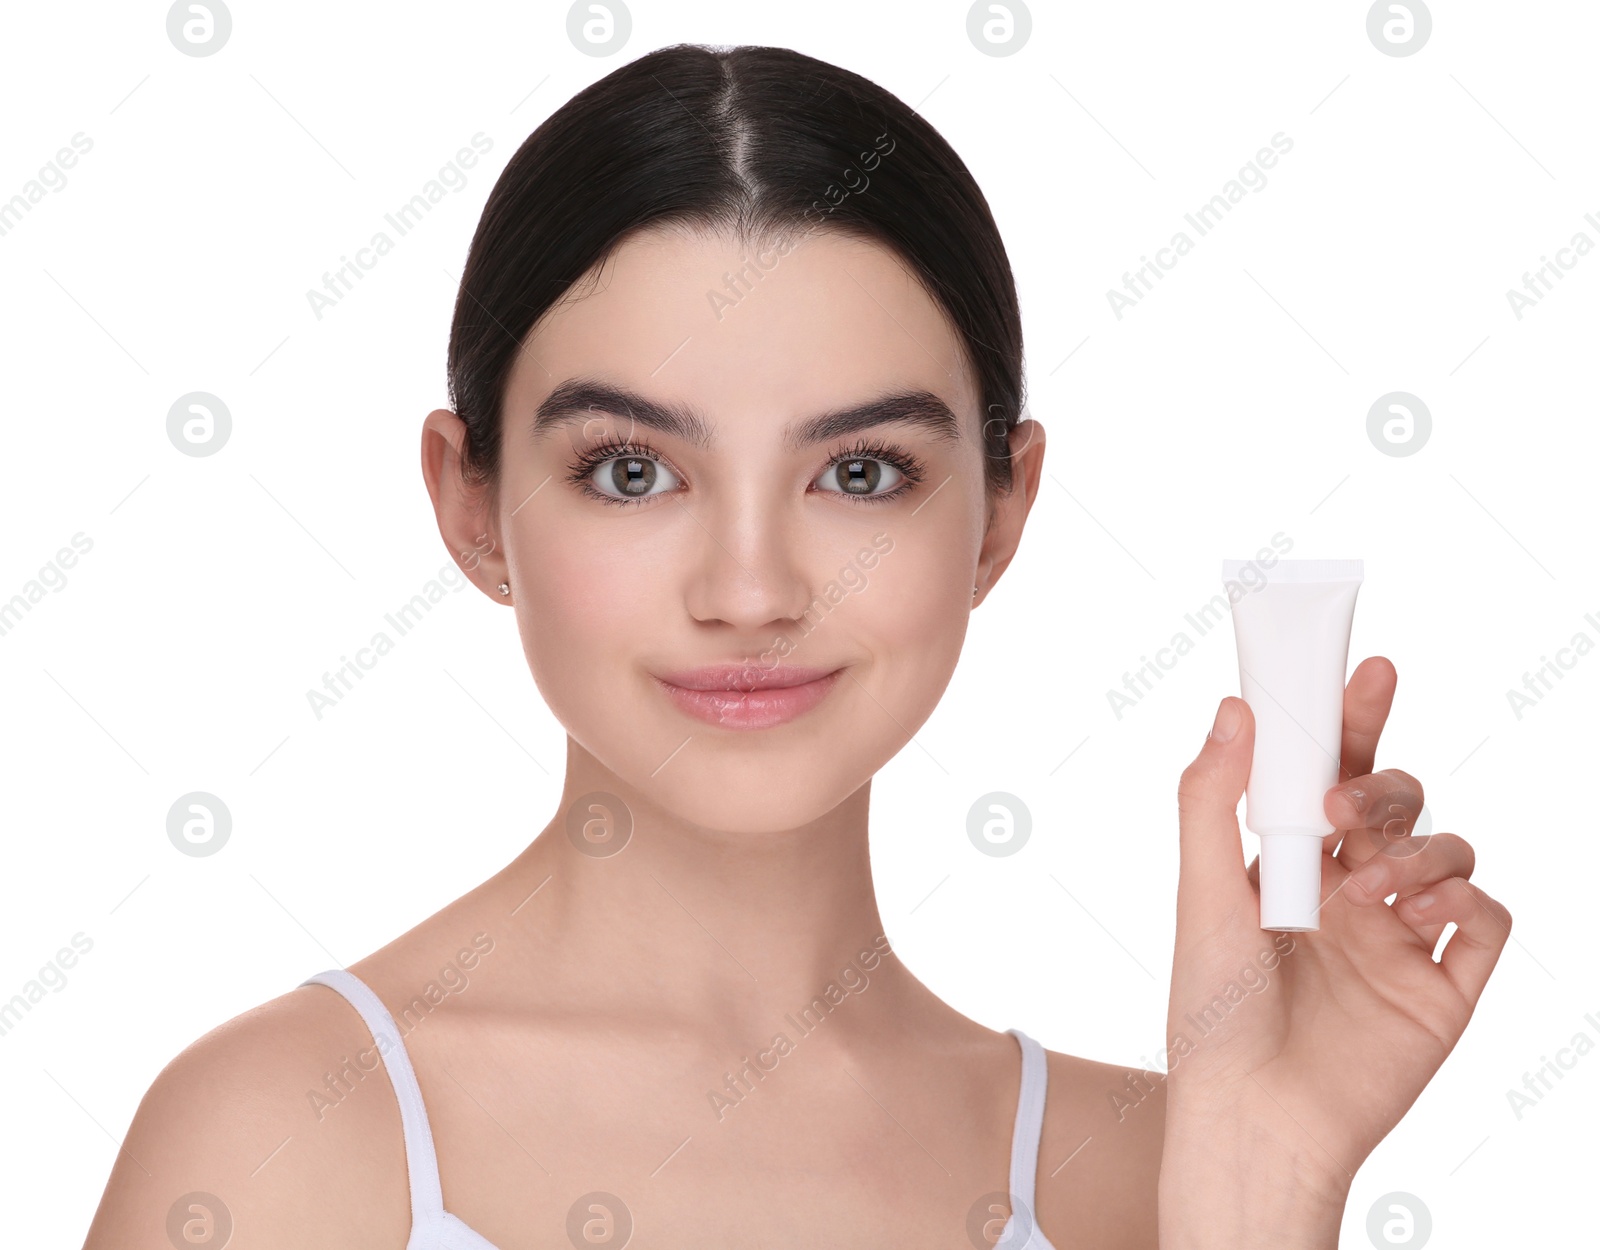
[1222,560,1362,933]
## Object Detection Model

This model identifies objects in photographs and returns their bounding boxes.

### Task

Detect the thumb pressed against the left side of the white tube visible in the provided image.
[1178,695,1256,927]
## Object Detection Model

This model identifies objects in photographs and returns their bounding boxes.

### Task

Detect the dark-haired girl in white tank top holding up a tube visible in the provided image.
[86,45,1510,1250]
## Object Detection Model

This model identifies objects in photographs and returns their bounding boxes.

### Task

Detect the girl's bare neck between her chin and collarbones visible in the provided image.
[486,739,926,1042]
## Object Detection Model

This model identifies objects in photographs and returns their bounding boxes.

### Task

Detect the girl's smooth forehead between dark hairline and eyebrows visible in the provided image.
[507,229,978,442]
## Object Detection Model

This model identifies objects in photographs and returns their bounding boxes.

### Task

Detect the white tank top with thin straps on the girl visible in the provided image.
[301,968,1056,1250]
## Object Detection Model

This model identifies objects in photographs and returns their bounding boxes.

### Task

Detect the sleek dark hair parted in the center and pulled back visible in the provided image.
[448,43,1024,504]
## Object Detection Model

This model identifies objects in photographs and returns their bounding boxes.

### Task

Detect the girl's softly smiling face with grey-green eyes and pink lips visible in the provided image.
[429,230,1043,832]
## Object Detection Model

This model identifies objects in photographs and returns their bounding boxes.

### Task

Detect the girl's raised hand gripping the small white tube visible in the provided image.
[1163,656,1510,1207]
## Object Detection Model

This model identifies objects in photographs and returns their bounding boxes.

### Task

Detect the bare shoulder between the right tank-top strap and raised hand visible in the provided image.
[1035,1050,1166,1250]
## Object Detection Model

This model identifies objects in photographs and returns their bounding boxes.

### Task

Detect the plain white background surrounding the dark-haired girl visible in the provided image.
[0,0,1600,1247]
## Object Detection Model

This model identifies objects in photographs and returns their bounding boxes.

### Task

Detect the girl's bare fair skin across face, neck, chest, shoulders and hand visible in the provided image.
[86,230,1510,1250]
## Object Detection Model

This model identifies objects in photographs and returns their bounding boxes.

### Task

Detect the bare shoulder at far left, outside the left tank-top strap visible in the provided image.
[85,986,411,1250]
